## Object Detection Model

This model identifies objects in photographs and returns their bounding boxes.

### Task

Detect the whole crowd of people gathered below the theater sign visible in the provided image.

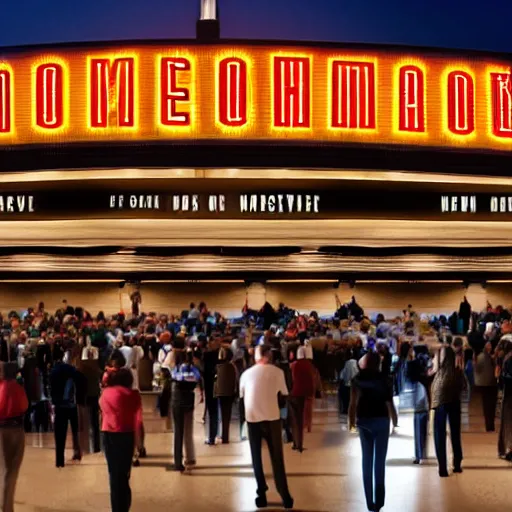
[0,297,512,512]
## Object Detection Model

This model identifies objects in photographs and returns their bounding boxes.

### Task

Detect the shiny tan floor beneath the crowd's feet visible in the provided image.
[16,400,512,512]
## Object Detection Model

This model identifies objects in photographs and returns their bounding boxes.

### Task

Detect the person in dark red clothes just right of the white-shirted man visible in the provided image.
[290,347,316,453]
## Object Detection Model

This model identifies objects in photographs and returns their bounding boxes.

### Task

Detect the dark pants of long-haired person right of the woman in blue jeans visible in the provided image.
[434,402,462,472]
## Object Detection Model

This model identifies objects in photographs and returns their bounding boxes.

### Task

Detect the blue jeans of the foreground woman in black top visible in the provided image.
[357,418,389,510]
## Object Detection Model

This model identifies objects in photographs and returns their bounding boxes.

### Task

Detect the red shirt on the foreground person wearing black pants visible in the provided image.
[100,386,142,432]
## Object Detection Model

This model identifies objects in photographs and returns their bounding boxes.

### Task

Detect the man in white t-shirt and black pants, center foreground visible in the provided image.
[240,345,293,509]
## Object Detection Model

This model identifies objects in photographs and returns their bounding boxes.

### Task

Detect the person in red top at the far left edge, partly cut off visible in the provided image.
[0,363,28,512]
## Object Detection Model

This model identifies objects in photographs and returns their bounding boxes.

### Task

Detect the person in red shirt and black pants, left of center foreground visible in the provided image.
[100,368,142,512]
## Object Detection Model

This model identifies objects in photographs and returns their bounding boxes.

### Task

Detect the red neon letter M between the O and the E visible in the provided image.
[90,57,135,128]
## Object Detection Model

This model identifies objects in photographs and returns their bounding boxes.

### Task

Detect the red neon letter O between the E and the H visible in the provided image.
[218,58,247,126]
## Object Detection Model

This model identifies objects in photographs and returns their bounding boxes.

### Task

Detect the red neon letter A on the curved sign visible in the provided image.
[399,66,425,132]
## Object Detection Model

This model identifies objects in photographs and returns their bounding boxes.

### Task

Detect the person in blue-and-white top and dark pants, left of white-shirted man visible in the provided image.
[171,349,201,472]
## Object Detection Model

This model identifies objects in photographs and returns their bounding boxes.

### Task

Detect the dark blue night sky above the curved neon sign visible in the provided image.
[0,0,512,52]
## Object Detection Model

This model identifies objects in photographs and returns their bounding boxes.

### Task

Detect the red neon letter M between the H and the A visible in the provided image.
[331,60,375,128]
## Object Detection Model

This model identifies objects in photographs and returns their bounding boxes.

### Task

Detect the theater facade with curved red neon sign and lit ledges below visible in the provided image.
[0,40,512,282]
